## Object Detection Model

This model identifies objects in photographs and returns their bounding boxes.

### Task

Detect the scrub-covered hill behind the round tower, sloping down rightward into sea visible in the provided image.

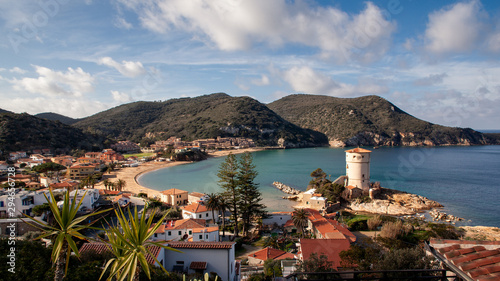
[268,95,496,146]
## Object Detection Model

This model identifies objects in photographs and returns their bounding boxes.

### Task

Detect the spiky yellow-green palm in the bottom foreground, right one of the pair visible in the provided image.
[101,208,178,281]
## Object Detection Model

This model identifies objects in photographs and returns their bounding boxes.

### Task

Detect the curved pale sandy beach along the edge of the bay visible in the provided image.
[95,147,263,197]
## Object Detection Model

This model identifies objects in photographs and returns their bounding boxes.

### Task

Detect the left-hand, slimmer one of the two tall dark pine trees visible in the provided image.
[217,153,240,237]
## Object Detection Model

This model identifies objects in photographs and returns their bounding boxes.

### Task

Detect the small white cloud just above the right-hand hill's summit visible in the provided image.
[281,66,388,97]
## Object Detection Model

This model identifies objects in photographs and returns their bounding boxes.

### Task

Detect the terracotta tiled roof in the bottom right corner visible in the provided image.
[426,239,500,281]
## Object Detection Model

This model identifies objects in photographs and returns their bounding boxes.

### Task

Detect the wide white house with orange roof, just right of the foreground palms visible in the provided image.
[151,219,219,242]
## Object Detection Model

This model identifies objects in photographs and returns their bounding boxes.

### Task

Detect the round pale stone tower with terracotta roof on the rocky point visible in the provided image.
[345,147,371,193]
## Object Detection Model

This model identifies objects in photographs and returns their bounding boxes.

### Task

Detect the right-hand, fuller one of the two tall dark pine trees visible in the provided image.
[237,152,266,235]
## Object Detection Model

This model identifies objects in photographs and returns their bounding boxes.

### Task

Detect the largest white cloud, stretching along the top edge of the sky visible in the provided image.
[118,0,395,61]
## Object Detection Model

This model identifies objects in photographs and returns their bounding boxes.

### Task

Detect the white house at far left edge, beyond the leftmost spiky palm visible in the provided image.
[0,190,50,217]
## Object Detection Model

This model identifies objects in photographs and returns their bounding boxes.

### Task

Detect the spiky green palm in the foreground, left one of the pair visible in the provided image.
[25,190,111,281]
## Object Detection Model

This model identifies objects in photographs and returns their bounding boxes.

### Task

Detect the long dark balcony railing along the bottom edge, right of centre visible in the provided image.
[284,269,456,281]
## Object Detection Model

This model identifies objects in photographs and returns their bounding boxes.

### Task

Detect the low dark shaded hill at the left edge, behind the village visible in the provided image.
[0,113,104,151]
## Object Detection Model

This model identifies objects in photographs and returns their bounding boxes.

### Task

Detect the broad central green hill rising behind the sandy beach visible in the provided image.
[73,93,328,147]
